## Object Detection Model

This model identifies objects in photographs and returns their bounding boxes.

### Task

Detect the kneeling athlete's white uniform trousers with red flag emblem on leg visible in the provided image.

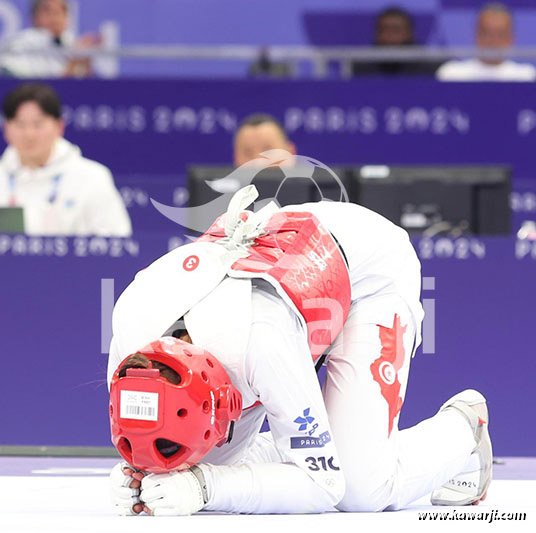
[243,295,475,511]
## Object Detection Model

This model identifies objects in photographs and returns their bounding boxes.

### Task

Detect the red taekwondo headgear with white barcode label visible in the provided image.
[110,337,242,473]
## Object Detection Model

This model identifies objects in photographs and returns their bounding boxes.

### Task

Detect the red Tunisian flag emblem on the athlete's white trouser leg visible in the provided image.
[370,315,408,435]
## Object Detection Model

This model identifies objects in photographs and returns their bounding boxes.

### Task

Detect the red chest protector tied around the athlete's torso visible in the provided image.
[198,211,351,361]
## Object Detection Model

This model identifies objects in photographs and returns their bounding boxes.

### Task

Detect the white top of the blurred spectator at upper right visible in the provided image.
[436,59,536,81]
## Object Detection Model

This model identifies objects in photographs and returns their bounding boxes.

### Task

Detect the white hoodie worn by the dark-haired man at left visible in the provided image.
[0,138,132,237]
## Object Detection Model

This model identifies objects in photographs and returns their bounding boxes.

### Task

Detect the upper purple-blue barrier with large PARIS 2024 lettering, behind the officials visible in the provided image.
[0,80,536,178]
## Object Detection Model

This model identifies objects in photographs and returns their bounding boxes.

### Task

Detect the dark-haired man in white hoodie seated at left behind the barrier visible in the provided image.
[0,84,132,236]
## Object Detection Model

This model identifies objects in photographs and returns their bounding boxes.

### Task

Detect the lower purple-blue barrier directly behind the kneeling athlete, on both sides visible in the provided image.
[0,235,536,455]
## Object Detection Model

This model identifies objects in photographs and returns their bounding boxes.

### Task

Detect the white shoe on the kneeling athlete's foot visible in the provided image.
[431,389,493,505]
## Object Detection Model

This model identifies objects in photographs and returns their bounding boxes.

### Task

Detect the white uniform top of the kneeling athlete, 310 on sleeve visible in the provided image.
[108,198,422,513]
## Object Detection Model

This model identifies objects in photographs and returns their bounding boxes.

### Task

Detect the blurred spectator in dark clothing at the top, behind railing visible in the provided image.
[352,7,438,76]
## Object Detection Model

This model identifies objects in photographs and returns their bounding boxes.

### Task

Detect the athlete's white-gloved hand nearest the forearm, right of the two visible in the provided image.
[140,467,206,516]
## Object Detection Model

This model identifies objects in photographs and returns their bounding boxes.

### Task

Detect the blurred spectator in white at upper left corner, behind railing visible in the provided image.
[0,0,99,78]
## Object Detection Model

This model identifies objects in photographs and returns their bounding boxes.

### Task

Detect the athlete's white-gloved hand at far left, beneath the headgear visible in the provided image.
[110,463,145,516]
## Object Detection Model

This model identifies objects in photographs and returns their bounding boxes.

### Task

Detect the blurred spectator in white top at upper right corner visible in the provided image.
[437,3,536,81]
